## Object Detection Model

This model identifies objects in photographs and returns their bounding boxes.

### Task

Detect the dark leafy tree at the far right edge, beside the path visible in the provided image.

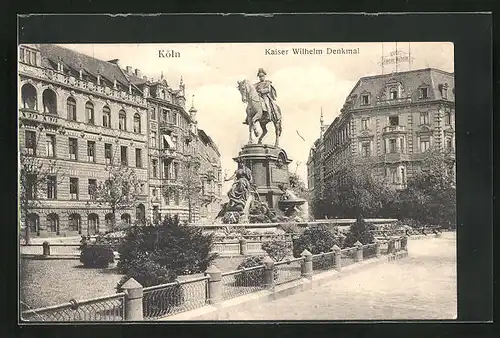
[398,148,456,227]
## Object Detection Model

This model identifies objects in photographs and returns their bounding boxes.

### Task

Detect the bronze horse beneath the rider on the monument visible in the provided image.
[238,80,281,147]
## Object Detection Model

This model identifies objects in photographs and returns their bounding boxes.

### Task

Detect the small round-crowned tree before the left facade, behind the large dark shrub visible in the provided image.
[90,165,141,230]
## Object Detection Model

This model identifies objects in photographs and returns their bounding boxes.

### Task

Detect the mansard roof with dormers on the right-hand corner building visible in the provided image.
[346,68,455,109]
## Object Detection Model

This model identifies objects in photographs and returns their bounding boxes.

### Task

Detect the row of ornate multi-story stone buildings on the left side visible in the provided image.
[18,45,220,236]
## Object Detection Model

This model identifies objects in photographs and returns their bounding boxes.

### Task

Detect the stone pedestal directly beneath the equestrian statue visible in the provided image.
[234,144,292,212]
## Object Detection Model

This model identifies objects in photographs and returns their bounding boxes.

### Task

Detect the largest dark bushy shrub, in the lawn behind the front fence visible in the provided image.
[118,217,217,287]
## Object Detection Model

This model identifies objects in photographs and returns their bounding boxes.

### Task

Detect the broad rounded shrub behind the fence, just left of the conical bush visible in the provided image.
[293,224,339,257]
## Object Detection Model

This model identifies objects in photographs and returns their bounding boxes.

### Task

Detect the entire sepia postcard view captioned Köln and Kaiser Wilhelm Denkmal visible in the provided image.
[17,41,457,324]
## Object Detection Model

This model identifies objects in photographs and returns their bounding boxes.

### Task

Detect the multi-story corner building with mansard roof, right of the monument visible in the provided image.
[323,68,455,188]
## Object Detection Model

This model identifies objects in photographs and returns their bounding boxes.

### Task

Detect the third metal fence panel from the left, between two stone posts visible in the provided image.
[221,265,264,300]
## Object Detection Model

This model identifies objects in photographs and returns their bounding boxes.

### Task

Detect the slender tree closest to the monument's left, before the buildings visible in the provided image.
[162,156,202,222]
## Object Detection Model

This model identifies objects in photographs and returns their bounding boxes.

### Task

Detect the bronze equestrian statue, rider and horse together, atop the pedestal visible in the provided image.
[238,68,281,146]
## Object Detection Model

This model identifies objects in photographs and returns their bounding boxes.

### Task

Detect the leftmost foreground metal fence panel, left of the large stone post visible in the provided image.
[21,292,125,322]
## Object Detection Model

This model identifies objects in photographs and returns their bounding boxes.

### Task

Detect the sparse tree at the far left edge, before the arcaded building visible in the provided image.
[19,131,64,244]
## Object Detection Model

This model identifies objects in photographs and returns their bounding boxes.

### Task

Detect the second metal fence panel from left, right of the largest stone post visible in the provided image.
[142,276,208,320]
